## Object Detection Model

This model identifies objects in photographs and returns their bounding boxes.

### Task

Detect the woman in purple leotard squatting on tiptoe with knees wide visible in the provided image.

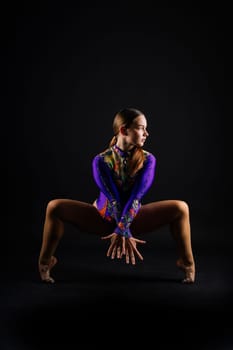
[39,108,195,283]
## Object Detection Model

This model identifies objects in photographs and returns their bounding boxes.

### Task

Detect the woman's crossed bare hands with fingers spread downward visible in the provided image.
[101,232,146,265]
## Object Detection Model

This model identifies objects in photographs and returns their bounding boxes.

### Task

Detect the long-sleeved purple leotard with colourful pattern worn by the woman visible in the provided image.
[92,145,156,237]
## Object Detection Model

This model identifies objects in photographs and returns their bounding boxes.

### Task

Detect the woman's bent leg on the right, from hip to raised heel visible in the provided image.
[131,200,195,283]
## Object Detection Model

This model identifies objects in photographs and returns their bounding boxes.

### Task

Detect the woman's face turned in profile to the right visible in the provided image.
[126,114,149,147]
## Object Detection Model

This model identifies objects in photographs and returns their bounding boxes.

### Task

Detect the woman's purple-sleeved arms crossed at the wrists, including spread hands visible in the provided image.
[93,154,156,265]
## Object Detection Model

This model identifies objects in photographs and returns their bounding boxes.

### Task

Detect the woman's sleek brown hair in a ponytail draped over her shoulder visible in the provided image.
[109,108,145,176]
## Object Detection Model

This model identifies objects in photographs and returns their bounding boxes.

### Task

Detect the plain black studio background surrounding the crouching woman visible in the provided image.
[1,1,233,350]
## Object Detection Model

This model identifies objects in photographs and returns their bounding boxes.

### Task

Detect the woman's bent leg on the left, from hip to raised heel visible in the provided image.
[39,199,113,282]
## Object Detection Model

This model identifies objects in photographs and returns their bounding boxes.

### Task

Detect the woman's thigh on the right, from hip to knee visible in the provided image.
[131,200,185,234]
